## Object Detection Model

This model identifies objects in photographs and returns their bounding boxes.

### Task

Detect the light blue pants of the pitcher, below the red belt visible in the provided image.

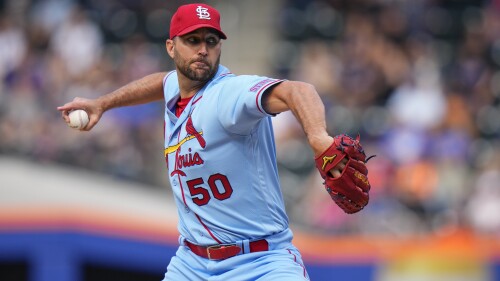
[163,229,309,281]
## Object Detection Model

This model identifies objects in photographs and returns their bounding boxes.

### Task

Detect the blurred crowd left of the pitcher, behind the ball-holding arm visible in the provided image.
[0,0,175,186]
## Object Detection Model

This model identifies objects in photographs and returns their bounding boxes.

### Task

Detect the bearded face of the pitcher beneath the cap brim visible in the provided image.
[167,28,222,82]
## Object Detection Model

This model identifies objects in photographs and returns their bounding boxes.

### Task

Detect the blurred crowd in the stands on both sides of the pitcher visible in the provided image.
[0,0,500,236]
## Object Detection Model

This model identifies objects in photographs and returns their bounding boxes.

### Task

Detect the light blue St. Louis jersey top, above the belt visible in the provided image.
[164,66,288,245]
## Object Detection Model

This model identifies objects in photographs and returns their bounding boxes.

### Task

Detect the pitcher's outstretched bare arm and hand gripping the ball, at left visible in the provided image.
[57,72,166,131]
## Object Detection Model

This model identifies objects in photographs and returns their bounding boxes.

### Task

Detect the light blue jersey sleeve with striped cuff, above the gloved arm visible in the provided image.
[217,75,283,135]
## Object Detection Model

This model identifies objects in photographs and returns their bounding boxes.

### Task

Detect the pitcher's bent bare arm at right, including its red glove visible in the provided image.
[262,81,370,214]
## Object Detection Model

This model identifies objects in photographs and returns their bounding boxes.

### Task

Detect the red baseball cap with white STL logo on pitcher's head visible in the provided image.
[170,4,227,39]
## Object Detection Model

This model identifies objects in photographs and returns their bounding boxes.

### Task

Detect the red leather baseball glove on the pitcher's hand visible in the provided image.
[315,134,373,214]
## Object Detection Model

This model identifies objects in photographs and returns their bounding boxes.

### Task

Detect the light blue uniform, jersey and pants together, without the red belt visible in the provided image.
[163,65,309,281]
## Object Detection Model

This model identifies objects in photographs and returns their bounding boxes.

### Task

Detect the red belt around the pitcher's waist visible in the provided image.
[184,239,269,260]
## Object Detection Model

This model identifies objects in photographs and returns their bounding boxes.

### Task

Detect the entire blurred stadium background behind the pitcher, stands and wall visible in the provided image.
[0,0,500,281]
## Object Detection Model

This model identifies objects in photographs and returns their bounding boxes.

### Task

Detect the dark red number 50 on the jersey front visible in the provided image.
[186,174,233,206]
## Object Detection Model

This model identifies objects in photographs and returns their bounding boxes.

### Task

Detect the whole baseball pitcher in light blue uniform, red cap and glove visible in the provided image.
[58,4,370,281]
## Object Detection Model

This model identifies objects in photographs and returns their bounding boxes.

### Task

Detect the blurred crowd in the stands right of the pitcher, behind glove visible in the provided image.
[273,0,500,236]
